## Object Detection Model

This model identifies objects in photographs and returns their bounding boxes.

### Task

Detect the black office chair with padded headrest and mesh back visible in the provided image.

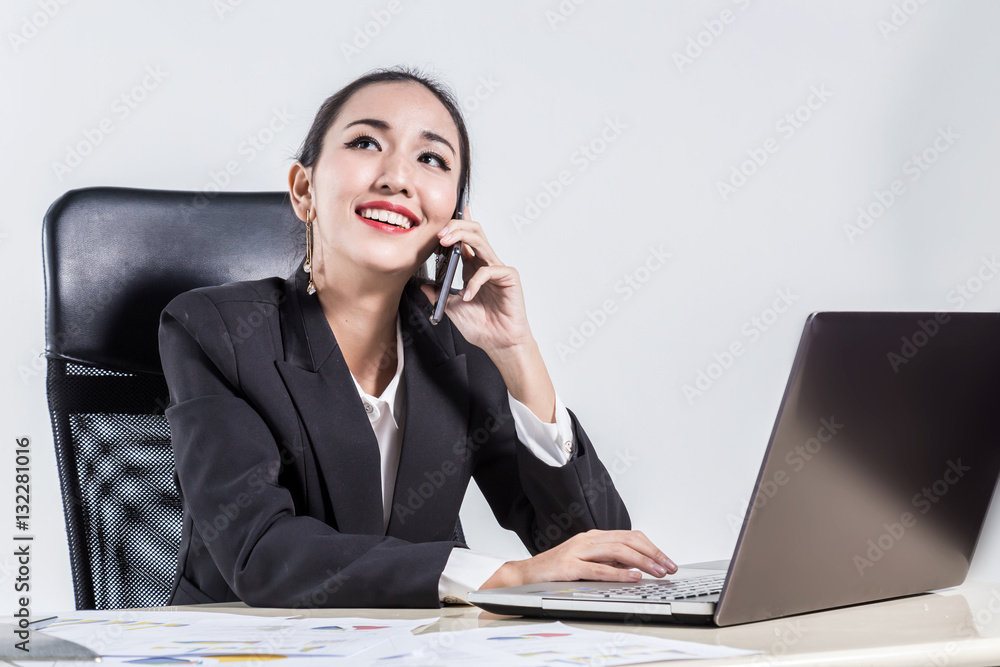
[42,187,465,609]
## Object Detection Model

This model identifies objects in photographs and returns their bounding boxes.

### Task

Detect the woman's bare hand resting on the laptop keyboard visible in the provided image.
[480,530,677,590]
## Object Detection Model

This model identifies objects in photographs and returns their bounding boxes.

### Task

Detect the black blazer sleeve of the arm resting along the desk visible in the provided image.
[159,290,458,607]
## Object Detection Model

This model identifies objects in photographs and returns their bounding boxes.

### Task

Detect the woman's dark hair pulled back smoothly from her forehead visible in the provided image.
[295,65,472,279]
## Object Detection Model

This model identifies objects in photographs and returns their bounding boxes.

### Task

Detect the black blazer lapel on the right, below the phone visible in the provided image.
[386,284,469,542]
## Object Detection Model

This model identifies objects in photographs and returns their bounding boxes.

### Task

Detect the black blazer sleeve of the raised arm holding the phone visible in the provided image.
[456,340,632,556]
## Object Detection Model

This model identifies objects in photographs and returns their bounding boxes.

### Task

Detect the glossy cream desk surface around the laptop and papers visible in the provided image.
[146,582,1000,667]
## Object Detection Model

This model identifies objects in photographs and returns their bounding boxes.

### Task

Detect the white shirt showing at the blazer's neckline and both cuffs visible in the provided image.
[351,314,573,602]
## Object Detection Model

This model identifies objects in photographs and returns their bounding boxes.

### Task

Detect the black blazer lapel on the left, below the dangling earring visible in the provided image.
[275,265,382,535]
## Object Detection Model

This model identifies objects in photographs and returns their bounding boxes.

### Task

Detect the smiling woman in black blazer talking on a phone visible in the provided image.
[160,68,676,607]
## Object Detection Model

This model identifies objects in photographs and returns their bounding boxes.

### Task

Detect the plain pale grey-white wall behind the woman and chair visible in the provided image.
[0,0,1000,611]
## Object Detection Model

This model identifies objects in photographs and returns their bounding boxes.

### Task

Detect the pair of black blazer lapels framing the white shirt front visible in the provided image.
[275,265,469,542]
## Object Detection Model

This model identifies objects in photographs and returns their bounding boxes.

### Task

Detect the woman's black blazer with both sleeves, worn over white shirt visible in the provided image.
[159,265,630,607]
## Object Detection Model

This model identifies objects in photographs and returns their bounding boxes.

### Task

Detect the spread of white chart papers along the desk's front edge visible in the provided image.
[19,611,755,667]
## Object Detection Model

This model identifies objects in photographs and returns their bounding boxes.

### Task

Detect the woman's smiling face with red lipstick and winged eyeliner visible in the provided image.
[311,82,461,278]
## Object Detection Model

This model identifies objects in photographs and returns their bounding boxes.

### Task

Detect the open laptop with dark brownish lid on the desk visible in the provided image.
[469,312,1000,626]
